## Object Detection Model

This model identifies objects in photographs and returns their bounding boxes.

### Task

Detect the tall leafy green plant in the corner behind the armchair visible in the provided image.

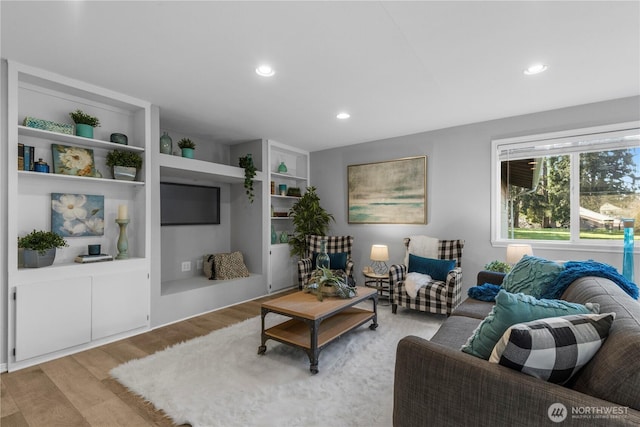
[289,187,335,258]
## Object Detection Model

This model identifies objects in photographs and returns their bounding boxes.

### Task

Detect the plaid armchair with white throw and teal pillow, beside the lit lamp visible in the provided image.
[389,238,464,316]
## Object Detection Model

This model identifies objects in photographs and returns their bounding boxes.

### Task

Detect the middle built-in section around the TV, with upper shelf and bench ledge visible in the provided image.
[152,132,268,326]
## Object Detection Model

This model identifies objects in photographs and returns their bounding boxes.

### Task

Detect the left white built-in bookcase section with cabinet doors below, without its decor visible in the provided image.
[6,61,151,370]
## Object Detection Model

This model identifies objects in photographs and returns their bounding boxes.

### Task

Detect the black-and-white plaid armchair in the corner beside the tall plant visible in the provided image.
[298,235,353,289]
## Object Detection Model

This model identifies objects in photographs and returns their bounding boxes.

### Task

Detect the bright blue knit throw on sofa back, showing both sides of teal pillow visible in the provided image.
[467,260,638,302]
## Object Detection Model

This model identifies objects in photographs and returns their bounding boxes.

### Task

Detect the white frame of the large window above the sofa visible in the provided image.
[491,121,640,252]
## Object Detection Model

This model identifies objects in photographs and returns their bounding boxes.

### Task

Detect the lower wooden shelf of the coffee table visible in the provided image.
[265,307,374,349]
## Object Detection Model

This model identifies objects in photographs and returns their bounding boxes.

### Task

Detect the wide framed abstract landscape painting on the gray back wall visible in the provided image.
[347,156,427,224]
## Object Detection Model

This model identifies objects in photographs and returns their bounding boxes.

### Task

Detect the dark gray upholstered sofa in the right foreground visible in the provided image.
[393,272,640,427]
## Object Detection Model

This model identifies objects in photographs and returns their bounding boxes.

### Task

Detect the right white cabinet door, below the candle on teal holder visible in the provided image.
[91,270,149,340]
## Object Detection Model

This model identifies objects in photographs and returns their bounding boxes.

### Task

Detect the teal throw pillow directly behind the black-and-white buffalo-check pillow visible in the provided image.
[462,289,600,360]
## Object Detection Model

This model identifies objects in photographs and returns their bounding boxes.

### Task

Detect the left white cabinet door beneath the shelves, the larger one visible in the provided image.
[15,276,91,361]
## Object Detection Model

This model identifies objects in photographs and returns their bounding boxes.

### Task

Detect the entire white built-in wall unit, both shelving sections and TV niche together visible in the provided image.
[2,61,309,370]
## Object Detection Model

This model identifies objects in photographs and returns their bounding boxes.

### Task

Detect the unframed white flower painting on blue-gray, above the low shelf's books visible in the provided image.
[51,193,104,237]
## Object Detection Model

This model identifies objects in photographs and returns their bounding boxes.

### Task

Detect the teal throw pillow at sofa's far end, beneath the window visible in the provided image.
[502,255,564,298]
